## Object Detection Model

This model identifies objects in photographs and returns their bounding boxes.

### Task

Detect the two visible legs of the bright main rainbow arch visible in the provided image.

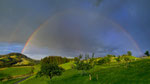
[22,11,142,54]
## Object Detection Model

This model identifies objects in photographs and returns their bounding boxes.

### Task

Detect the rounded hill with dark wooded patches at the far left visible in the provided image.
[0,53,38,67]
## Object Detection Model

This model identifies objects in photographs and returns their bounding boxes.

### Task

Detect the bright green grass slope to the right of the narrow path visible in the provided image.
[20,59,150,84]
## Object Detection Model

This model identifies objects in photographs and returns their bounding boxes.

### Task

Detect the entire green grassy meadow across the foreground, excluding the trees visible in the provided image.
[0,52,150,84]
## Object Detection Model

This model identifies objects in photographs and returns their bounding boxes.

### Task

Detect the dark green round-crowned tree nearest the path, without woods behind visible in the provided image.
[37,64,64,79]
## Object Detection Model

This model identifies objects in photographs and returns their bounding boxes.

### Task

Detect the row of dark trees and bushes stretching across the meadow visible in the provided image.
[37,51,149,80]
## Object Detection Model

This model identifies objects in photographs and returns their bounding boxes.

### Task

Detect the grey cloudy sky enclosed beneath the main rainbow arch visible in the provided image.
[24,10,139,56]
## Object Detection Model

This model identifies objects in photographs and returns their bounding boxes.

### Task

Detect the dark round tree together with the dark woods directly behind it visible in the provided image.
[37,56,67,79]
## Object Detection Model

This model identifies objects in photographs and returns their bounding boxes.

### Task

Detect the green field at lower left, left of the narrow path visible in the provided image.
[0,66,32,84]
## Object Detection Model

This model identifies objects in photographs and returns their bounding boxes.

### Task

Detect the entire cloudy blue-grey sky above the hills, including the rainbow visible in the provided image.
[0,0,150,59]
